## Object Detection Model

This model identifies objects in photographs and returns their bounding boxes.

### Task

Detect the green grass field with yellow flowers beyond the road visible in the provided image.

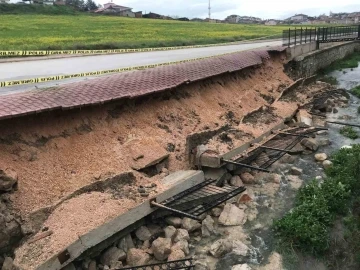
[0,14,288,50]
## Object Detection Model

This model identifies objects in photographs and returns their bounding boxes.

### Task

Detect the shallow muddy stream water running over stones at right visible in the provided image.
[195,67,360,270]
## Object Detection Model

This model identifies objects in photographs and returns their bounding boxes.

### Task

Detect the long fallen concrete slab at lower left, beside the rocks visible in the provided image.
[15,171,204,270]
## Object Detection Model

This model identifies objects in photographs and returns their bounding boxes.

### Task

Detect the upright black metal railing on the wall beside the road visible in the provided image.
[283,25,360,47]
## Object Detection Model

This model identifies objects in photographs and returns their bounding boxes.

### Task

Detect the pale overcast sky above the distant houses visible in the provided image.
[95,0,360,19]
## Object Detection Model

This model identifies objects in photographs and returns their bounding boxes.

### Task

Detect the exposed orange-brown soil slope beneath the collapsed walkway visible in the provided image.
[0,58,296,214]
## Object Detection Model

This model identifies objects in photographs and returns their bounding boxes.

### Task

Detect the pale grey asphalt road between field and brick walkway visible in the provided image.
[0,40,281,95]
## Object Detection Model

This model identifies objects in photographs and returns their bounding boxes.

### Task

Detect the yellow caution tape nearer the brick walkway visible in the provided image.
[0,52,242,87]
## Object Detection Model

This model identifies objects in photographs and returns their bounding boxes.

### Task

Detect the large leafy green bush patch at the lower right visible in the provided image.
[274,145,360,262]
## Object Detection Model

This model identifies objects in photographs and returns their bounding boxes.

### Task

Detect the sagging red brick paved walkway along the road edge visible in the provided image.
[0,47,284,119]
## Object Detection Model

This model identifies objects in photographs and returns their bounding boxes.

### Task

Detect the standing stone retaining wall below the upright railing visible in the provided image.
[285,41,360,79]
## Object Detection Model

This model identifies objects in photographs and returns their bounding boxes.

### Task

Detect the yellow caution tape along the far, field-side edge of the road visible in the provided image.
[0,35,277,57]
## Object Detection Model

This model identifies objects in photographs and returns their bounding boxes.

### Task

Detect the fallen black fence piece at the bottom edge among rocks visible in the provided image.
[115,258,195,270]
